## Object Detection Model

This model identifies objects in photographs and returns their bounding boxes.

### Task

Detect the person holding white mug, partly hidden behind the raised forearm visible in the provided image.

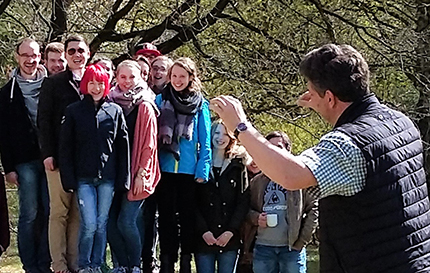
[243,131,318,273]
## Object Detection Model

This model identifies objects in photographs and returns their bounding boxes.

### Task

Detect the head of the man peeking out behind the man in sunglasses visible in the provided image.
[43,42,67,76]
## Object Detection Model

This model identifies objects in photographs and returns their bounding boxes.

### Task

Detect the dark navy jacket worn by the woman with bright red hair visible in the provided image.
[59,95,130,191]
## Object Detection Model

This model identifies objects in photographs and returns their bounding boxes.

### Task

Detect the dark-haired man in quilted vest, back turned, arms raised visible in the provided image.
[211,44,430,273]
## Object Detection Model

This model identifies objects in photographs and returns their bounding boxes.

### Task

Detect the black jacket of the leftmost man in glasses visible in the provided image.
[0,78,40,173]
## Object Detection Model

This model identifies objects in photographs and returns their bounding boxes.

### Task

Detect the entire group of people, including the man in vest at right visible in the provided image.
[0,35,430,273]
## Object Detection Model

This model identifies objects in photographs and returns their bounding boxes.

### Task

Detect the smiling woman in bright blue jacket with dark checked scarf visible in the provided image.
[156,58,211,273]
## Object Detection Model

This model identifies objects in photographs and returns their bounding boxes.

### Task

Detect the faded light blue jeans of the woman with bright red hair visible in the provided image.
[78,179,114,269]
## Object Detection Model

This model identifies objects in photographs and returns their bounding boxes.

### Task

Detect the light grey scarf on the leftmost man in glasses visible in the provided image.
[12,65,47,127]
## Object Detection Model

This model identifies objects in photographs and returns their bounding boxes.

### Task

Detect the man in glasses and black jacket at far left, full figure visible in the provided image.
[0,38,50,273]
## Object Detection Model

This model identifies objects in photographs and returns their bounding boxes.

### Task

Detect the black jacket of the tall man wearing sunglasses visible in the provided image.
[37,70,81,163]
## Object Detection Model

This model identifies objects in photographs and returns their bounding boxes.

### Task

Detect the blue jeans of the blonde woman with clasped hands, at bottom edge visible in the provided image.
[194,250,239,273]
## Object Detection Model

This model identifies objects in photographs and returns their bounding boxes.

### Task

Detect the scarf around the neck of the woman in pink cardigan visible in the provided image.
[109,81,155,116]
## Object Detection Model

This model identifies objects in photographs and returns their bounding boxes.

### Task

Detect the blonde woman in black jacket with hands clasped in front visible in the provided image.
[195,120,250,273]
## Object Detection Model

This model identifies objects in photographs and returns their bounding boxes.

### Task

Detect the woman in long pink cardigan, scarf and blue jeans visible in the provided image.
[108,60,160,273]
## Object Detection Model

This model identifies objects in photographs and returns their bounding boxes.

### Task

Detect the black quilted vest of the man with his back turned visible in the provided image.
[319,95,430,273]
